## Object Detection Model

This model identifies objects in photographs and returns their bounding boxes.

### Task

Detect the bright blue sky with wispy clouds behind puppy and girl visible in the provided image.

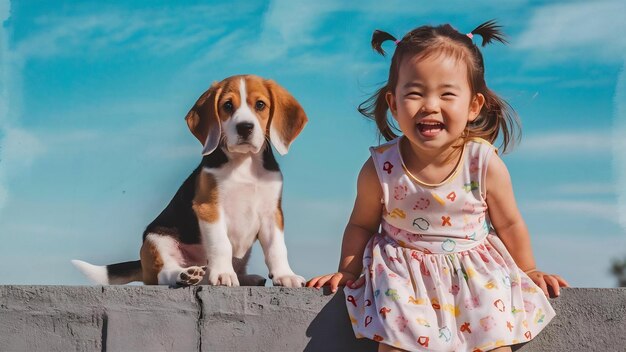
[0,0,626,287]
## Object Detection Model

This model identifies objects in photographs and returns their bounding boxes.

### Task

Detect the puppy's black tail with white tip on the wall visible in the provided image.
[72,259,143,285]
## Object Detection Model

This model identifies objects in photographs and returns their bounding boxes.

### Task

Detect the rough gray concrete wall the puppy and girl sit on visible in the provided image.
[0,286,626,352]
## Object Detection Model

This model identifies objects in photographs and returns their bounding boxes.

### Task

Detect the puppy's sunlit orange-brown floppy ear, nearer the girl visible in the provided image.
[265,80,308,155]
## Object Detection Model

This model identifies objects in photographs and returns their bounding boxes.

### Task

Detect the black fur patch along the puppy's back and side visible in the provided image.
[143,147,228,244]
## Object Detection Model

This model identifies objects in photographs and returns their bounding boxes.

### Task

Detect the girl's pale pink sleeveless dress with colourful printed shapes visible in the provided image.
[344,137,555,351]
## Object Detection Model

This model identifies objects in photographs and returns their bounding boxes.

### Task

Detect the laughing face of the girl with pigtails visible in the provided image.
[386,55,485,152]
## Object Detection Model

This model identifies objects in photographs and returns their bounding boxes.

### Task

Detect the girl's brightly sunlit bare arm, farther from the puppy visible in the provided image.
[486,155,569,296]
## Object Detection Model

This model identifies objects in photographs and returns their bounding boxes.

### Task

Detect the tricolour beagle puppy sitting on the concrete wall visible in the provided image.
[72,75,307,287]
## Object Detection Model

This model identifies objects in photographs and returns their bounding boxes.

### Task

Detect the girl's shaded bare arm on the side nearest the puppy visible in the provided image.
[306,157,383,292]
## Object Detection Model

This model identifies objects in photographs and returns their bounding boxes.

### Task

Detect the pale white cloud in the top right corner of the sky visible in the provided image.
[515,0,626,62]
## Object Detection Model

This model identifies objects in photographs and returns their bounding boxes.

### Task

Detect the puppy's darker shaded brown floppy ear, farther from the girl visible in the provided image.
[185,82,222,155]
